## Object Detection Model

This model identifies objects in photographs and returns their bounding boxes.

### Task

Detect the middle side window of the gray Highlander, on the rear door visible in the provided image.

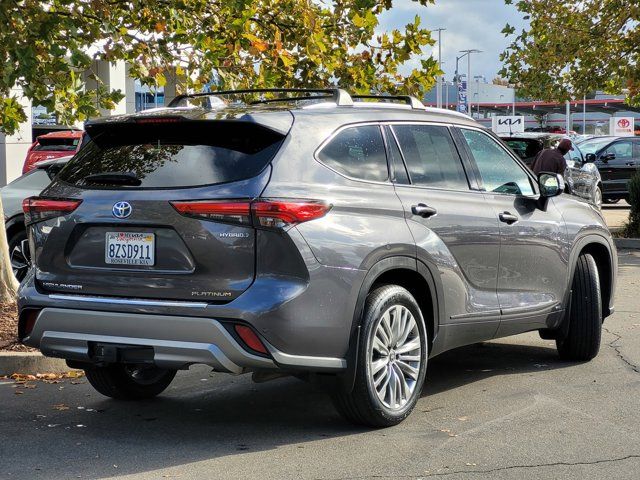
[393,124,469,190]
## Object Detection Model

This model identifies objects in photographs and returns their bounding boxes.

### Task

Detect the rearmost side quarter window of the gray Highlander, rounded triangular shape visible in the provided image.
[318,125,389,182]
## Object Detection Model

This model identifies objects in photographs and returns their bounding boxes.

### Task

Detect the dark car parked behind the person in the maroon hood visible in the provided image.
[502,133,602,208]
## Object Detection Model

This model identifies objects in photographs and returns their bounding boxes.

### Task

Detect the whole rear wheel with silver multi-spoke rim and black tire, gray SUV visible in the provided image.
[333,285,428,427]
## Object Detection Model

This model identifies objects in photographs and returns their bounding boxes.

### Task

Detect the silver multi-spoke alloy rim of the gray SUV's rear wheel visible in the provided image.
[368,305,422,410]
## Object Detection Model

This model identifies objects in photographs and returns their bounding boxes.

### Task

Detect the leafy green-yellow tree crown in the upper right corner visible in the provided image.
[500,0,640,103]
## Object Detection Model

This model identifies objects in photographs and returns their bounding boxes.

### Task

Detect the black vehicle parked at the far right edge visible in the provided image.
[580,136,640,203]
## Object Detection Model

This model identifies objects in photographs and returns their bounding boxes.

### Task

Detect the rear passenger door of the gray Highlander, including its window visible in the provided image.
[386,123,500,334]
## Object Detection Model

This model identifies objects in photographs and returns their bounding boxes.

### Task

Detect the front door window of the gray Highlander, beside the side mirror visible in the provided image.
[461,128,533,195]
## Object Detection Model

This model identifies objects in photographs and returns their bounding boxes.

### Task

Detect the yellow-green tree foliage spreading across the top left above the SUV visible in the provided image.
[0,0,438,133]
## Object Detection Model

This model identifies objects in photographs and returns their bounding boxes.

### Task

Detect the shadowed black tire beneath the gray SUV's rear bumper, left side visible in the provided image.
[84,364,176,400]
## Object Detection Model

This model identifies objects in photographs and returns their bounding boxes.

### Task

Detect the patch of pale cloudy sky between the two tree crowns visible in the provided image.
[377,0,525,82]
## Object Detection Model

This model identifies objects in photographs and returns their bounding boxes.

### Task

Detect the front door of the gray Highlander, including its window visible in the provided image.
[461,128,567,335]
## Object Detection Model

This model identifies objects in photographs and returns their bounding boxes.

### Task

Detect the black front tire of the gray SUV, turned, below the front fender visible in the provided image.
[556,254,602,362]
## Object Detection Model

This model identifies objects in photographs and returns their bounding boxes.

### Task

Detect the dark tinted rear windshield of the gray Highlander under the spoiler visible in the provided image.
[58,121,284,189]
